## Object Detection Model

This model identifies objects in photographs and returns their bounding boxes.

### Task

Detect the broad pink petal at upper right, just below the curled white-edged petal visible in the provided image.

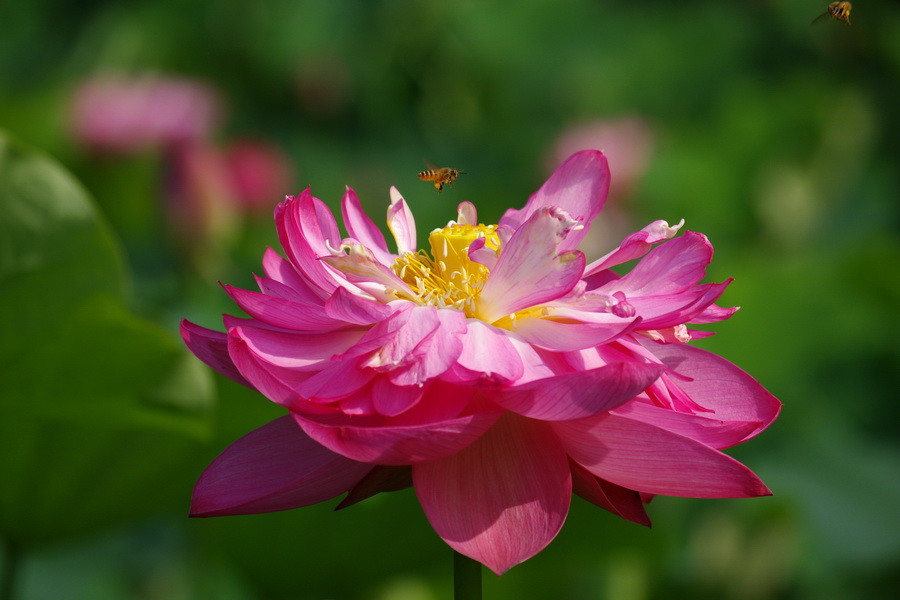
[599,231,713,298]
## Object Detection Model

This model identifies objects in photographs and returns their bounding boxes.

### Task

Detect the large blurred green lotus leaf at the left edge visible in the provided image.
[0,135,212,544]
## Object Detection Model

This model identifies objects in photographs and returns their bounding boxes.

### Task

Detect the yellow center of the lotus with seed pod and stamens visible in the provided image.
[391,222,500,317]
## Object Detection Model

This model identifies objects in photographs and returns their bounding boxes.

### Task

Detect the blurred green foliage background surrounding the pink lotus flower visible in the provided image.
[0,0,900,600]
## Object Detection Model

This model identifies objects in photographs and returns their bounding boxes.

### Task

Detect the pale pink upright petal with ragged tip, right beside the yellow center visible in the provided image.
[476,207,584,323]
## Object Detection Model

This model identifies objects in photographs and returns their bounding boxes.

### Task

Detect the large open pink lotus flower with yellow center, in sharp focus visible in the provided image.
[182,151,780,574]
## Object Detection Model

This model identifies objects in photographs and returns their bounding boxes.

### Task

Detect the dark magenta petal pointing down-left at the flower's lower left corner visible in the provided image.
[191,417,372,517]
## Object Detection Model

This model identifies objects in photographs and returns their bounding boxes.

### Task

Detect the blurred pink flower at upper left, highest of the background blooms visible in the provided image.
[70,75,223,153]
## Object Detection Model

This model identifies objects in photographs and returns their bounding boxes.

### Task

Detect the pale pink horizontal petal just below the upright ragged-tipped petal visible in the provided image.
[513,313,640,352]
